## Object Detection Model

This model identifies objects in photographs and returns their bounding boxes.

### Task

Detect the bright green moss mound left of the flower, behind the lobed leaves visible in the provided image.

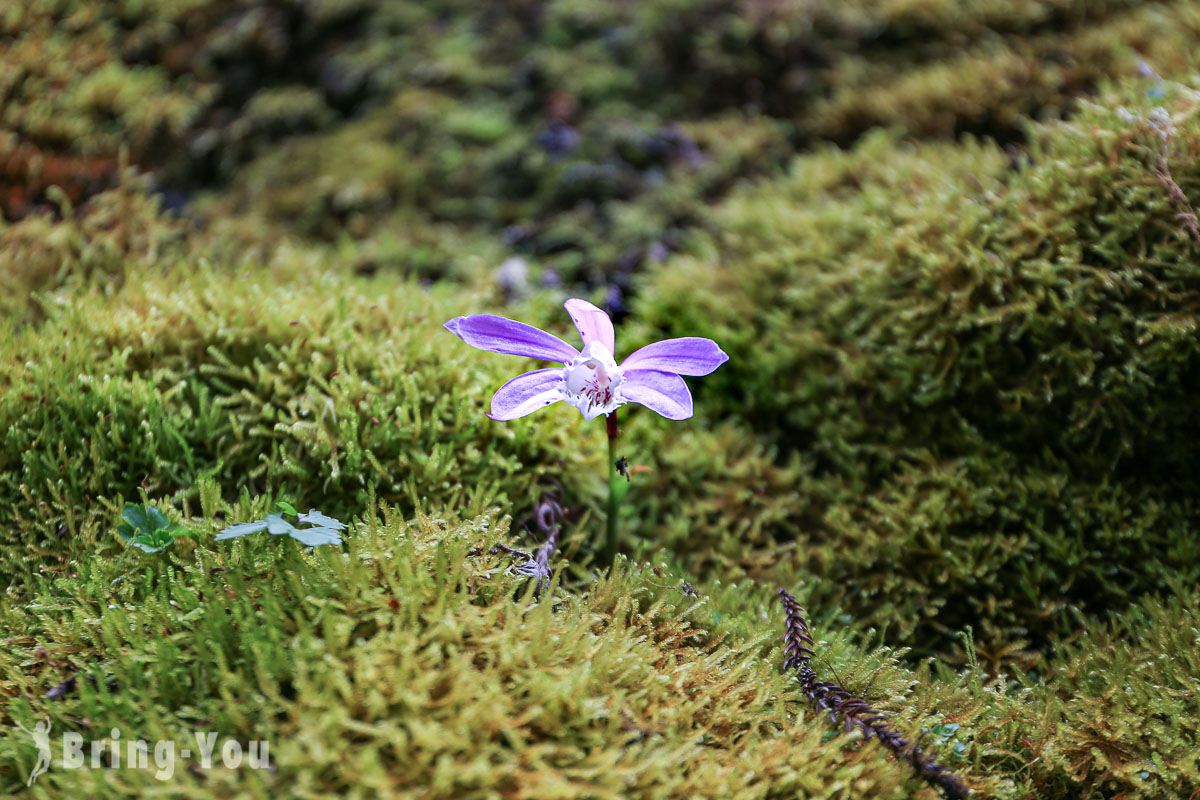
[0,264,601,585]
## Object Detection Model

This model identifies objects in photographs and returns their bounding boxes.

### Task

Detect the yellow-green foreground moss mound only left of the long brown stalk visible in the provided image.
[0,503,974,798]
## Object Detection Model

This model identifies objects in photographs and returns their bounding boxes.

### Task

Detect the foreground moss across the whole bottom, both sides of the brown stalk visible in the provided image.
[0,503,1200,798]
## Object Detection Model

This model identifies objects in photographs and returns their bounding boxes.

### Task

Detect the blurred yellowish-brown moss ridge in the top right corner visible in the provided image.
[802,4,1200,142]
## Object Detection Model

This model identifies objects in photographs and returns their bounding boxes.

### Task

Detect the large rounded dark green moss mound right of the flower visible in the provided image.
[640,80,1200,640]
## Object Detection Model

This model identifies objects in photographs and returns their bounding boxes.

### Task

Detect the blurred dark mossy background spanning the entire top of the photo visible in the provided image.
[0,0,1200,284]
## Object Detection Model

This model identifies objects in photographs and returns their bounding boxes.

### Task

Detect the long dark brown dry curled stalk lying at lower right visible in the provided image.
[779,589,970,800]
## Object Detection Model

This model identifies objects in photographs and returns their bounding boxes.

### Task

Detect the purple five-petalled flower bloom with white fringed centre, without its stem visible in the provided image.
[446,299,730,421]
